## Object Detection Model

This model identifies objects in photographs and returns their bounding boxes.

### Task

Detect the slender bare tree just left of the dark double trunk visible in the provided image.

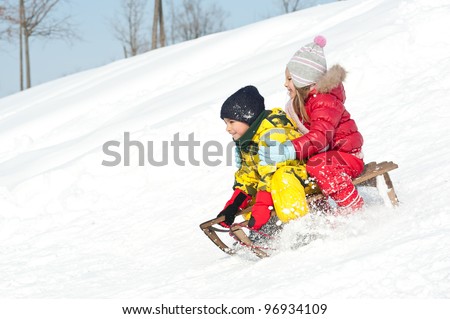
[112,0,149,58]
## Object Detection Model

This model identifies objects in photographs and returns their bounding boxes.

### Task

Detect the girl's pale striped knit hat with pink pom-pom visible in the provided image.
[287,35,327,88]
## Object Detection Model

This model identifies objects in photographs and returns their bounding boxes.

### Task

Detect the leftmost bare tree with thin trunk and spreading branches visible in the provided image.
[4,0,78,89]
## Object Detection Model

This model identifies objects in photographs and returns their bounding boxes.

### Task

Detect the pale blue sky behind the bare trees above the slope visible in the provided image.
[0,0,332,97]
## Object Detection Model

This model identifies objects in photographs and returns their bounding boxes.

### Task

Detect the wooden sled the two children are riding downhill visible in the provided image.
[200,162,398,258]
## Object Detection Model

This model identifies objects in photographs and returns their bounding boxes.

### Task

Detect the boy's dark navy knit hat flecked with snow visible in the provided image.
[220,85,265,125]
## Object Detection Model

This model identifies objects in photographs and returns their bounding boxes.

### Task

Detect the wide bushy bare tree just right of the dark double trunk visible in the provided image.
[172,0,226,42]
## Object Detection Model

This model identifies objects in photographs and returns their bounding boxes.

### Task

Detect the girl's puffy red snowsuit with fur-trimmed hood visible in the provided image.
[292,66,364,209]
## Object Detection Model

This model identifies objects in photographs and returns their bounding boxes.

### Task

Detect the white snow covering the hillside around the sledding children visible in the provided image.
[0,0,450,308]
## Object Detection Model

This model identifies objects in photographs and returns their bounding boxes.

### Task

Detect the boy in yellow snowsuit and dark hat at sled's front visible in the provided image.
[218,86,319,230]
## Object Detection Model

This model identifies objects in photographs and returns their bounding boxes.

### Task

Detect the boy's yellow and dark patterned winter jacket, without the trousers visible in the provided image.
[233,108,307,197]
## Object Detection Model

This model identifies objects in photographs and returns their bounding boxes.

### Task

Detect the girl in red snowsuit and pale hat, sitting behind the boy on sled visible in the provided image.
[259,36,364,213]
